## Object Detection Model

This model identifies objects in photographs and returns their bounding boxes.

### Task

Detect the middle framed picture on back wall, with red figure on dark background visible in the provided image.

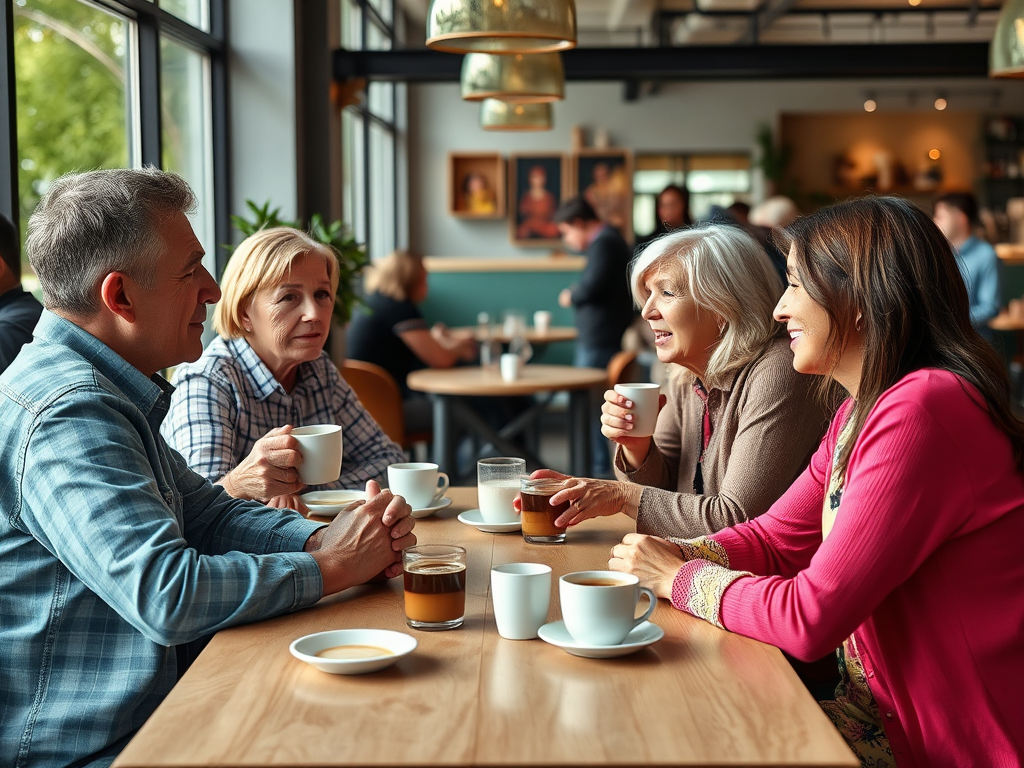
[509,154,566,247]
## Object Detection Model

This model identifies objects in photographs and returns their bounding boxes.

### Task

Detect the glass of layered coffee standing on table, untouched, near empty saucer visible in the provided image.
[401,544,466,630]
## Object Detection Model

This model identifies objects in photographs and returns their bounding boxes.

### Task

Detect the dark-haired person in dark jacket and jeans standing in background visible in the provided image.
[555,197,634,476]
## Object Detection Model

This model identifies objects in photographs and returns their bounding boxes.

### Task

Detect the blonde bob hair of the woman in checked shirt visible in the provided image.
[213,226,338,339]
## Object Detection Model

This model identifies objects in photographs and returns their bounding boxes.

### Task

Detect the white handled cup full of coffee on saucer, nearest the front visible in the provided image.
[558,570,657,645]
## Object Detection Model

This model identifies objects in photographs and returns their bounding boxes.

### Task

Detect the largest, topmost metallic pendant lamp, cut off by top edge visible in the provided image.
[427,0,575,53]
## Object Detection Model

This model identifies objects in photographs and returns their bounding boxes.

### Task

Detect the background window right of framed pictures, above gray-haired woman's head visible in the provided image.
[633,153,751,236]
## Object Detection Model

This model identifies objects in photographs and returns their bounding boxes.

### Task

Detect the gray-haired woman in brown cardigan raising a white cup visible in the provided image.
[536,224,830,539]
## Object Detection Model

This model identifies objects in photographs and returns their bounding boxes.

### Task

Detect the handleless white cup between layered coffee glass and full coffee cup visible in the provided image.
[490,562,551,640]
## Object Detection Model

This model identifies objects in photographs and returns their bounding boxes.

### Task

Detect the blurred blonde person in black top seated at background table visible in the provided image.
[348,251,476,432]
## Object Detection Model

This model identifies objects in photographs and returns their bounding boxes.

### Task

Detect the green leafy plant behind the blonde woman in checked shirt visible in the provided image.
[225,200,370,326]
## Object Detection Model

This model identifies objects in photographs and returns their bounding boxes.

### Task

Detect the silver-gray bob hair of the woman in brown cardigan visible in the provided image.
[630,224,783,387]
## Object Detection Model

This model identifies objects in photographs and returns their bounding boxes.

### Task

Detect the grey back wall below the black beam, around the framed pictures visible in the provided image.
[409,79,1024,256]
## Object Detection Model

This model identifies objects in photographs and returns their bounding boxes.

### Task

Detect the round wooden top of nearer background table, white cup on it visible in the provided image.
[406,365,608,395]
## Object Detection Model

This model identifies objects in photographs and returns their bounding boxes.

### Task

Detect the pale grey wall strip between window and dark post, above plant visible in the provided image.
[228,0,298,228]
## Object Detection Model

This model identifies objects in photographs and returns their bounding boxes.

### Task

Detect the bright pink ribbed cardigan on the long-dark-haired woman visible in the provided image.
[673,369,1024,768]
